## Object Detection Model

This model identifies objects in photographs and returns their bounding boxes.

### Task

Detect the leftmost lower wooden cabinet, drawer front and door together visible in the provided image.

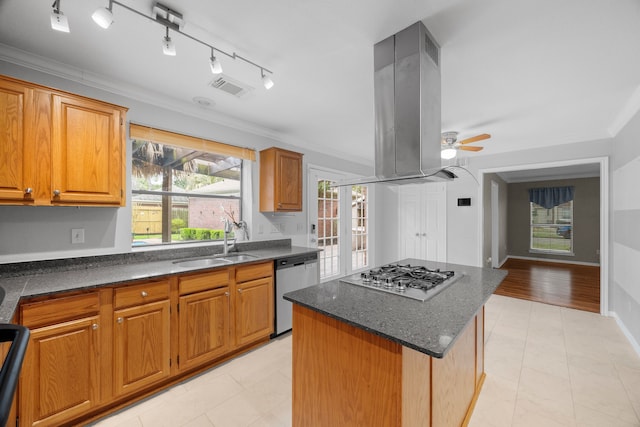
[19,292,104,426]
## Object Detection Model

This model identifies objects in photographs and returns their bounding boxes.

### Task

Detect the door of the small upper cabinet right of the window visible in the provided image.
[275,151,302,211]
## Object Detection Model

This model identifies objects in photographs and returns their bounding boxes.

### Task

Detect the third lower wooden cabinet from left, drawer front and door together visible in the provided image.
[178,269,231,371]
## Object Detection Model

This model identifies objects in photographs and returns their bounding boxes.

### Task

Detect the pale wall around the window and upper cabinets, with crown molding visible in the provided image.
[0,61,372,263]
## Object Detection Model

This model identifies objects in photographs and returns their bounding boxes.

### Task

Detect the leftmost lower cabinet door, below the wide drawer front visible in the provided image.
[19,316,100,426]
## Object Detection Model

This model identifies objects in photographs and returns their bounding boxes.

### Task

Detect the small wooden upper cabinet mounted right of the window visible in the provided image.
[260,147,302,212]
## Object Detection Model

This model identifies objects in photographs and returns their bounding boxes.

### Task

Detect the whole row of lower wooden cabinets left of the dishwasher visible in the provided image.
[18,262,274,426]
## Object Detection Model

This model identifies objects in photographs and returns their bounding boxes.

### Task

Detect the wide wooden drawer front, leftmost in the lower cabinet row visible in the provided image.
[20,292,100,328]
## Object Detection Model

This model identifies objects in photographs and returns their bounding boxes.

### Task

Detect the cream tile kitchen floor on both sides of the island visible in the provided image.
[95,295,640,427]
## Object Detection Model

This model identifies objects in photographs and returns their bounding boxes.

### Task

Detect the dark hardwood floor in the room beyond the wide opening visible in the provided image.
[495,258,600,313]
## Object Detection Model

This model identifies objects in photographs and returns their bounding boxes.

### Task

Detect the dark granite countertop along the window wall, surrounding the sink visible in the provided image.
[0,239,318,323]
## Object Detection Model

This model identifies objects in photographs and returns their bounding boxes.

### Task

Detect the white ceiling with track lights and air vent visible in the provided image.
[0,0,640,163]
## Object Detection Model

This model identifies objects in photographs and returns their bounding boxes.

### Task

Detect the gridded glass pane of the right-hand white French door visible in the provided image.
[351,185,369,270]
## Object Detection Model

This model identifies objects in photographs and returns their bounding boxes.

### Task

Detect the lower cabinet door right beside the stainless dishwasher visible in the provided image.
[235,277,273,347]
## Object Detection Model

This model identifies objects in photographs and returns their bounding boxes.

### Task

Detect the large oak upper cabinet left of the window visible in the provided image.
[0,76,127,206]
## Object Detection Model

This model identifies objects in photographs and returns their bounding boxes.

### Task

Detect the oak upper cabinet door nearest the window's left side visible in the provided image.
[51,95,124,206]
